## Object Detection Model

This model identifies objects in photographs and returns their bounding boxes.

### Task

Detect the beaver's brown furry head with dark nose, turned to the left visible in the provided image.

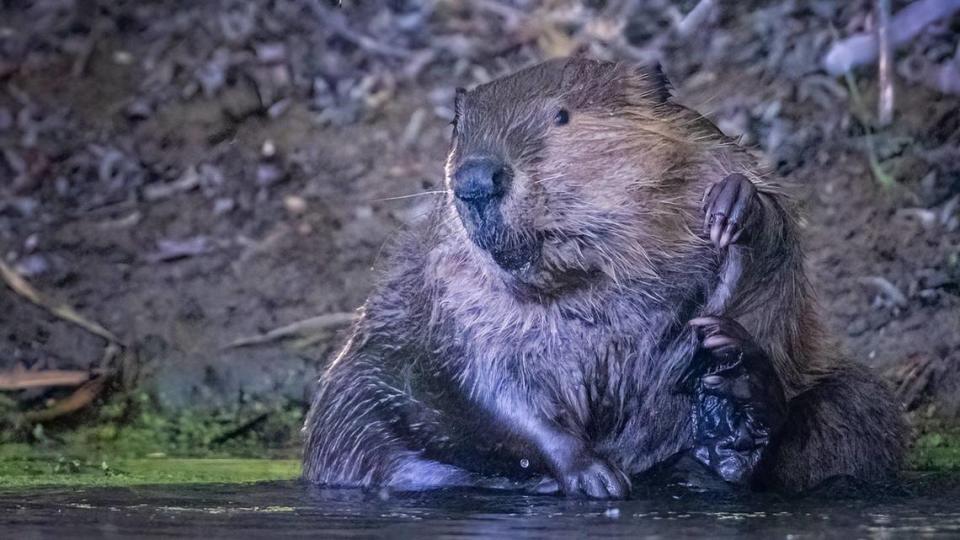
[446,59,696,291]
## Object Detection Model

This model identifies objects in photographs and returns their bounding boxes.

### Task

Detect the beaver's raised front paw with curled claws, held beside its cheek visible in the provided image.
[703,173,761,248]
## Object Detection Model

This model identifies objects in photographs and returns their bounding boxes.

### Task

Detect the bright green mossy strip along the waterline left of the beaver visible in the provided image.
[0,394,303,489]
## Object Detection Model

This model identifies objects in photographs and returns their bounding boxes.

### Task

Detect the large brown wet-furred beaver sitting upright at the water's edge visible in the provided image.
[304,58,904,498]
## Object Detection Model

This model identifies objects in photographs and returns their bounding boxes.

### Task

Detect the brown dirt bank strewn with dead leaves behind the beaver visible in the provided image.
[0,0,960,430]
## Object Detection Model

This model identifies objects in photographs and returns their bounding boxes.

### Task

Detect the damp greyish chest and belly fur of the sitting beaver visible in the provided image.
[390,238,715,476]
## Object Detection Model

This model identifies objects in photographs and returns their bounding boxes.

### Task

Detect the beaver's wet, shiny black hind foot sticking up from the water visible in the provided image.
[690,317,786,484]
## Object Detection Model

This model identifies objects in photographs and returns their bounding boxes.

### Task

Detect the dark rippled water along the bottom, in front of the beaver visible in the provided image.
[0,475,960,540]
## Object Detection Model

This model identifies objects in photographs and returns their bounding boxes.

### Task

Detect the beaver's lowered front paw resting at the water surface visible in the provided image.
[534,453,630,499]
